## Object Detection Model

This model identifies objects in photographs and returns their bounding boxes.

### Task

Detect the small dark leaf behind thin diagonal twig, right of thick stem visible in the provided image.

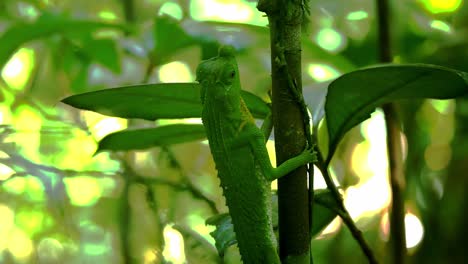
[310,189,339,237]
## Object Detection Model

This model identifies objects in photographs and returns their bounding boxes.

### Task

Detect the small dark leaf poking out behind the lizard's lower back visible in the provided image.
[205,213,237,257]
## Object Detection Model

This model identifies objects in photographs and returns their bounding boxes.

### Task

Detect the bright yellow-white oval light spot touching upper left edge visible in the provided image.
[2,48,34,90]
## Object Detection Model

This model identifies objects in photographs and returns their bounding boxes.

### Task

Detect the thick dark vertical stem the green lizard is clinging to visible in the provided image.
[257,0,310,263]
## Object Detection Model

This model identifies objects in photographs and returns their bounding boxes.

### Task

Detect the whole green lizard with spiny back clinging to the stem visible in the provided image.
[197,46,316,264]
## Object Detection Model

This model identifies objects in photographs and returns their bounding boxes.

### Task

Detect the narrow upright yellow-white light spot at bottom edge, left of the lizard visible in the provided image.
[163,225,186,264]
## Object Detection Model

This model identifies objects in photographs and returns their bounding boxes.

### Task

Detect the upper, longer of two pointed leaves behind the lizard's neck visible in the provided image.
[62,83,270,120]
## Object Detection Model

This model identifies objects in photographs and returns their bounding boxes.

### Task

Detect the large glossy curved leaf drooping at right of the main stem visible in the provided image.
[325,64,468,163]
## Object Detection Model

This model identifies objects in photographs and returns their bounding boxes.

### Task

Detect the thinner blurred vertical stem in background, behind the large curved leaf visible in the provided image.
[377,0,406,264]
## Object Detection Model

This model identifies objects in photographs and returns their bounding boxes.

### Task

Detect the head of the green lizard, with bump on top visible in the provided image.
[197,46,240,103]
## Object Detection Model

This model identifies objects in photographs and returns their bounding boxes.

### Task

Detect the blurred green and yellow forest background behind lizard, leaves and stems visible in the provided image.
[0,0,468,263]
